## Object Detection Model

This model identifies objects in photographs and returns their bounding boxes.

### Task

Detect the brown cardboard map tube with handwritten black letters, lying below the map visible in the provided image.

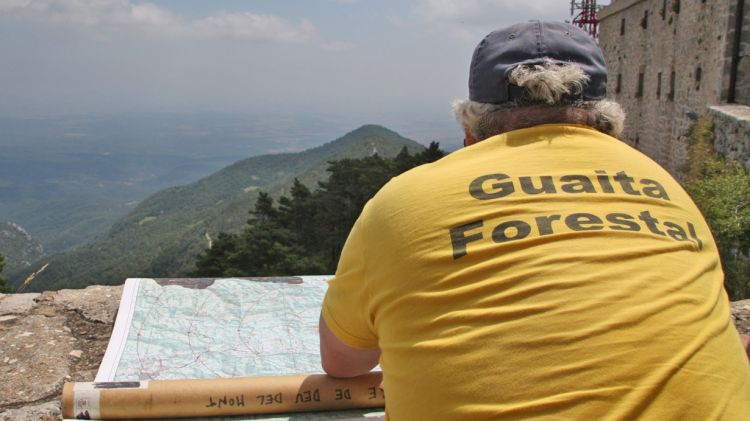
[62,372,385,420]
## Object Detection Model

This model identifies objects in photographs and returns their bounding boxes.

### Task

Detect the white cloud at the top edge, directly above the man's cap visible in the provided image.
[415,0,569,39]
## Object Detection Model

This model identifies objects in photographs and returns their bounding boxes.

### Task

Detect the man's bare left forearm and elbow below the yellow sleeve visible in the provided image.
[319,315,380,377]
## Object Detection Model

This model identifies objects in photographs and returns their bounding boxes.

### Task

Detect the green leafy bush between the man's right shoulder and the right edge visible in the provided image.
[685,120,750,300]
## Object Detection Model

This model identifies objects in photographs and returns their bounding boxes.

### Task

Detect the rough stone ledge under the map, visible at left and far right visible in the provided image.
[0,286,750,421]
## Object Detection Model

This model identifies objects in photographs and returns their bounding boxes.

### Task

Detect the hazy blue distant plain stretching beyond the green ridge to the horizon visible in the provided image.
[0,112,458,254]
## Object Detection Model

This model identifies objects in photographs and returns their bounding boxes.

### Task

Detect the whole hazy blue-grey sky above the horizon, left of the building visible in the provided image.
[0,0,604,118]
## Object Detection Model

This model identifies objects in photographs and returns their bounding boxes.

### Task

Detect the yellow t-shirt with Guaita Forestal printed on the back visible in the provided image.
[323,125,750,421]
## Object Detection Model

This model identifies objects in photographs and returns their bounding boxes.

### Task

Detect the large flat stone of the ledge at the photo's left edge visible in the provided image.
[0,315,73,406]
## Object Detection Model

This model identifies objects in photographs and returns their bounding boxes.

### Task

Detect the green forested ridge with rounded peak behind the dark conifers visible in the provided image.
[12,125,424,291]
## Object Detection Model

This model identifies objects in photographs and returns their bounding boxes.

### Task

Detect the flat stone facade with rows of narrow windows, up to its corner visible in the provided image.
[599,0,734,178]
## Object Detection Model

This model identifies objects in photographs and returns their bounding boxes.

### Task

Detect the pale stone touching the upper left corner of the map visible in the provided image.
[55,285,122,324]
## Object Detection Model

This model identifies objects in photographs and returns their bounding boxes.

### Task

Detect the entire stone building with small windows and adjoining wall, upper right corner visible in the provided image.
[598,0,750,177]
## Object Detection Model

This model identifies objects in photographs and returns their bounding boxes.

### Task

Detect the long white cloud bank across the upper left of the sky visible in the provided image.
[0,0,317,42]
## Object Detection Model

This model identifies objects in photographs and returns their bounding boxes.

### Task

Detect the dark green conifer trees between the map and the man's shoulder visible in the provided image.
[193,142,445,277]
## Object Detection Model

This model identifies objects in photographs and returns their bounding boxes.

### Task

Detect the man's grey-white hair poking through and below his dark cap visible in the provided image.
[452,60,625,140]
